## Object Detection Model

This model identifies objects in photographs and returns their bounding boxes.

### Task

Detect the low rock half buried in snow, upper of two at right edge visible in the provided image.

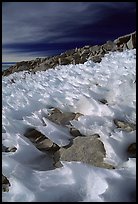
[114,119,136,132]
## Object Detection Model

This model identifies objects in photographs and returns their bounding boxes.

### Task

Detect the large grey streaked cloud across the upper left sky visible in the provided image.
[2,2,135,43]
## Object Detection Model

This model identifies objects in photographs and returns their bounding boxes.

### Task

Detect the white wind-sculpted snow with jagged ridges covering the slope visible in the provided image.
[2,49,136,202]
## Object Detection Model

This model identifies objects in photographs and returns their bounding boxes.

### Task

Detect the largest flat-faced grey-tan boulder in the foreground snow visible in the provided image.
[54,135,114,169]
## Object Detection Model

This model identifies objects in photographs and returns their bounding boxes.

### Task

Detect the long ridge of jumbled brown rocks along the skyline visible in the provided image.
[2,32,136,76]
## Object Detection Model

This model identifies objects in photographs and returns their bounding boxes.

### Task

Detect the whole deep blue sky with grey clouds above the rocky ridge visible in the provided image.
[2,2,136,62]
